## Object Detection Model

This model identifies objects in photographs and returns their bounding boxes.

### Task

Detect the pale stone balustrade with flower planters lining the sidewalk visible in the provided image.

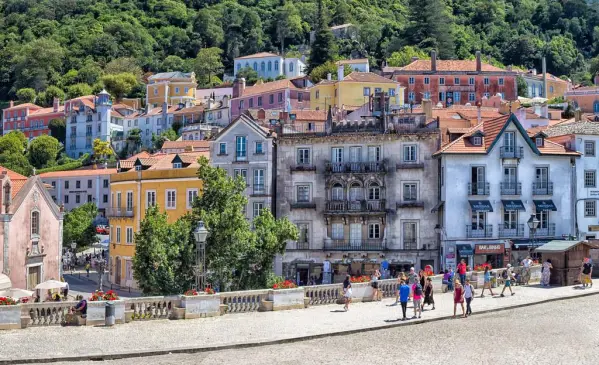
[0,266,541,330]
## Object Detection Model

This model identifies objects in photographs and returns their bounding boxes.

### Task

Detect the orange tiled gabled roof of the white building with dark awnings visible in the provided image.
[433,114,580,156]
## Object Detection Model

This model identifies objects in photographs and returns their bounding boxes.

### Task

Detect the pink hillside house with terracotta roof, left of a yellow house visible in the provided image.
[231,77,310,120]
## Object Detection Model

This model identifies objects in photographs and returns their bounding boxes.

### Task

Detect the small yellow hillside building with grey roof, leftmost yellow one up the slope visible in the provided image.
[146,71,198,108]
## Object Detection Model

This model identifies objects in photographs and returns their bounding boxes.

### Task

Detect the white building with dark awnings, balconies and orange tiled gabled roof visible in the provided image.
[435,114,579,268]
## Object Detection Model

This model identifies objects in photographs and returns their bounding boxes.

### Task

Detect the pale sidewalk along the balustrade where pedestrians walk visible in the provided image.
[0,280,599,364]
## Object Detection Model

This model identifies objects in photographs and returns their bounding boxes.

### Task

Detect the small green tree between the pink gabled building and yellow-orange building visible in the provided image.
[62,203,99,249]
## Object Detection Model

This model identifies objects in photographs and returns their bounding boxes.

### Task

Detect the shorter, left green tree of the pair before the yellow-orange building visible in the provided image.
[133,206,195,295]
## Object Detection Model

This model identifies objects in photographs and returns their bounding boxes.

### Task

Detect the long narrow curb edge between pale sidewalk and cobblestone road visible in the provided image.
[5,291,599,365]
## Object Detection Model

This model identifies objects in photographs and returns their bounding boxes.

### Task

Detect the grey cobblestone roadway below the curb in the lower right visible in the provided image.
[55,296,599,365]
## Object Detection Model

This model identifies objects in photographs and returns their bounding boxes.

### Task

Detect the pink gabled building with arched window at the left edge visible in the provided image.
[0,166,62,290]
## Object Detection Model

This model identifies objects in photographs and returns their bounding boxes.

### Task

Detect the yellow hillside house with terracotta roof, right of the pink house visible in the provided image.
[310,67,404,110]
